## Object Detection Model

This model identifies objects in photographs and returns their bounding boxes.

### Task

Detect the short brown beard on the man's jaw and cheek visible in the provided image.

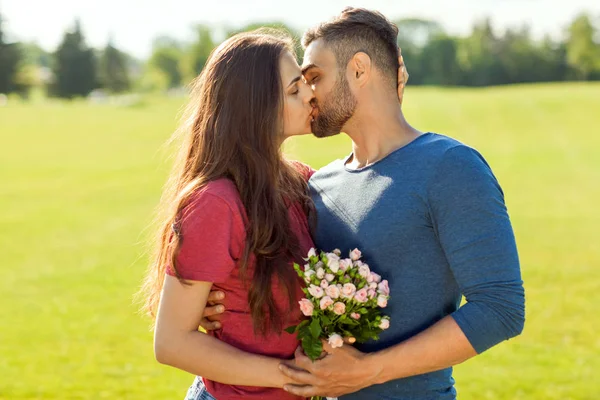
[311,75,356,138]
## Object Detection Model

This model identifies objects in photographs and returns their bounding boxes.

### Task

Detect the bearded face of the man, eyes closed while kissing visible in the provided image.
[302,39,356,137]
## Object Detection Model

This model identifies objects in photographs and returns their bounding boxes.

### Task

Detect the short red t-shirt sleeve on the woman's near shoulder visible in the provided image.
[167,192,244,283]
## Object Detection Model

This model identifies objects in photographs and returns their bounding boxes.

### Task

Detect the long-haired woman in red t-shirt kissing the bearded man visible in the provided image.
[140,32,313,400]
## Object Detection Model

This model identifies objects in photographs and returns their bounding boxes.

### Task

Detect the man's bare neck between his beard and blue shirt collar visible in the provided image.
[344,104,422,169]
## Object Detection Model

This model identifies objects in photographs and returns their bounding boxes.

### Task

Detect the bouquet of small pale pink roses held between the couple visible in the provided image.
[286,248,390,361]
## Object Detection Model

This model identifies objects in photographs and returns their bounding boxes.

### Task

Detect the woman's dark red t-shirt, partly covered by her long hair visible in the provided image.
[167,163,314,400]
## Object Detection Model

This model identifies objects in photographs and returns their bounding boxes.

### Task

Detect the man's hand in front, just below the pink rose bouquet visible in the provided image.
[280,341,379,397]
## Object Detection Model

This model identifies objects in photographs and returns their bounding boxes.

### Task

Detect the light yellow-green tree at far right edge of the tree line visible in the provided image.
[566,14,600,80]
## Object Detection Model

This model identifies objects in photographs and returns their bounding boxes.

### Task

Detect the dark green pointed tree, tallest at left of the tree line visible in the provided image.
[51,21,97,99]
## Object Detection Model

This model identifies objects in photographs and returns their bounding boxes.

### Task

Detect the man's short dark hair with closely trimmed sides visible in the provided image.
[302,7,399,88]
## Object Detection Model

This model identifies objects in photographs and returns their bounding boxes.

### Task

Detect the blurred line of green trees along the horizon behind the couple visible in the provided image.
[0,14,600,98]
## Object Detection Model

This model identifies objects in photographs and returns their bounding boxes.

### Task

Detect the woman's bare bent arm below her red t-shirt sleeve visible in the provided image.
[154,275,293,388]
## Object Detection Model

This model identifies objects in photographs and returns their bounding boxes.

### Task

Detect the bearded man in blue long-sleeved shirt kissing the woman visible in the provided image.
[204,8,524,400]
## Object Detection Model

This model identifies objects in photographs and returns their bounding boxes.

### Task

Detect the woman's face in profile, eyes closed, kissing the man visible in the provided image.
[279,51,314,138]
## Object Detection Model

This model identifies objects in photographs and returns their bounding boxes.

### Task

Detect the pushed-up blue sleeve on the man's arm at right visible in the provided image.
[429,145,525,353]
